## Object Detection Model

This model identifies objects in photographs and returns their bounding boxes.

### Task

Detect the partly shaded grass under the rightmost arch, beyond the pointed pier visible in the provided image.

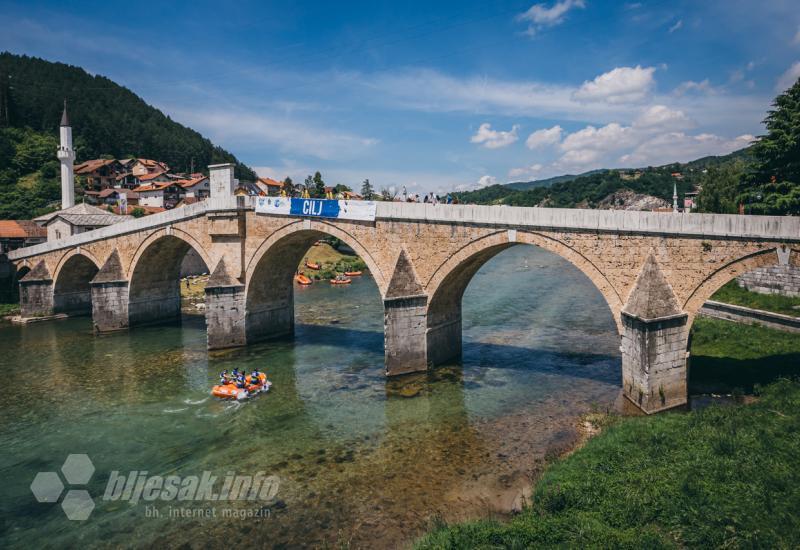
[689,317,800,394]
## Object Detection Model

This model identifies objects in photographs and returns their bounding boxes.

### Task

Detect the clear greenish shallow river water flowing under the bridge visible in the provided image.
[0,246,621,547]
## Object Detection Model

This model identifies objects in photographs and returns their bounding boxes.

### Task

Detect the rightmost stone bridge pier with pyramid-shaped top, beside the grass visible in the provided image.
[620,254,688,414]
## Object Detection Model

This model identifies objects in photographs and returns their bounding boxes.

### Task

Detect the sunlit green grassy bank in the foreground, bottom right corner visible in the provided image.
[416,380,800,549]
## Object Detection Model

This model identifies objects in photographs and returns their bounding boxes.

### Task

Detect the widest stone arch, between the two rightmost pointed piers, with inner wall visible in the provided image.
[425,231,623,364]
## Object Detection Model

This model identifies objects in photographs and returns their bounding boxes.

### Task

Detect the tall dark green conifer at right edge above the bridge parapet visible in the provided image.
[738,79,800,215]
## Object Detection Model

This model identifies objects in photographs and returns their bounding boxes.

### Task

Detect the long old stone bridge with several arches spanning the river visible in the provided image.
[9,183,800,412]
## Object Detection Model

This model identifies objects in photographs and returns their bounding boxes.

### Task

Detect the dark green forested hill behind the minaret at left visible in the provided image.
[0,52,255,179]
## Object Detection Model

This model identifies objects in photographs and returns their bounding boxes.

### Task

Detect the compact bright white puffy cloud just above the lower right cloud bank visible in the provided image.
[573,65,656,103]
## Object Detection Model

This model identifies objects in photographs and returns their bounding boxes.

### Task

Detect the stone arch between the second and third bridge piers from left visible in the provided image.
[128,228,210,326]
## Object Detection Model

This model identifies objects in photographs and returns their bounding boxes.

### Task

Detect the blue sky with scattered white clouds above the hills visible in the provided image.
[0,0,800,191]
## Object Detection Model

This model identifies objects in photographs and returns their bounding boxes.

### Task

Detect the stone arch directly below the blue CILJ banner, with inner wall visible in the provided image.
[245,220,386,342]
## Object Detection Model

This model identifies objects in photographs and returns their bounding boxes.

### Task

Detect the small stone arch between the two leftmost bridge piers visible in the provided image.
[53,249,100,315]
